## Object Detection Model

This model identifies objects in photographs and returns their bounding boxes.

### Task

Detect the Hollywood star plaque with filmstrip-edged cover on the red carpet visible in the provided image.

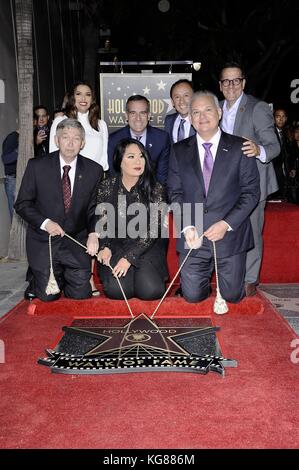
[38,313,237,375]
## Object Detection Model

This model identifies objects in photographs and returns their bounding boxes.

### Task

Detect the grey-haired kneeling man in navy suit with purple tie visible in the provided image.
[167,91,260,303]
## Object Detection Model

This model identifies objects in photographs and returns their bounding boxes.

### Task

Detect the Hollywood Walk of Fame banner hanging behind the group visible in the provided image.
[100,73,192,133]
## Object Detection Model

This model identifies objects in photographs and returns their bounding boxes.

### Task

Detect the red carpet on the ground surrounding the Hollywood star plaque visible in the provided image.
[0,296,299,449]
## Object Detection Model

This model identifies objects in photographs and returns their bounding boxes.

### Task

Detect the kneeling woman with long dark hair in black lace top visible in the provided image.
[97,139,168,300]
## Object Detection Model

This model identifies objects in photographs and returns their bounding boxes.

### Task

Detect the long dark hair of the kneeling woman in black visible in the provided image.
[113,138,156,207]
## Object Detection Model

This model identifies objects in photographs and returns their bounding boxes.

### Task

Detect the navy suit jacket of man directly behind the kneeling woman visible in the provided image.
[108,125,170,184]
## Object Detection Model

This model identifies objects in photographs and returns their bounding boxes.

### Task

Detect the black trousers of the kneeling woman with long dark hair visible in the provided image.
[97,253,165,300]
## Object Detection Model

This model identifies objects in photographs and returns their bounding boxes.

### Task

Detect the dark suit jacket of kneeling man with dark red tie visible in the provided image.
[14,151,103,264]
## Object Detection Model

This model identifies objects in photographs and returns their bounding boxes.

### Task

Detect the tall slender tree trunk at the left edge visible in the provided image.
[8,0,33,259]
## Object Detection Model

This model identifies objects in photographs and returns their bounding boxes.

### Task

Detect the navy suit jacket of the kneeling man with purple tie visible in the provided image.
[167,132,260,258]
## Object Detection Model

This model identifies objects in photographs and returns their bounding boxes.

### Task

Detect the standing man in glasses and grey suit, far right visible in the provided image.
[219,62,280,296]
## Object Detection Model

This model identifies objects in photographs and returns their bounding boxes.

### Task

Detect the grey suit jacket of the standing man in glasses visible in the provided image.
[220,93,280,201]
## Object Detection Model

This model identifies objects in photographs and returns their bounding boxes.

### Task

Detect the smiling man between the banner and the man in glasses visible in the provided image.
[164,78,196,144]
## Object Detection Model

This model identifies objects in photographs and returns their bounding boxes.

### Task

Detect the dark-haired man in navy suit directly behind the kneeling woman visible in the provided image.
[108,95,170,184]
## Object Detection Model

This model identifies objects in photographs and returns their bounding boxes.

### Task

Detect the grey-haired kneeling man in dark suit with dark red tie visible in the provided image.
[15,119,103,301]
